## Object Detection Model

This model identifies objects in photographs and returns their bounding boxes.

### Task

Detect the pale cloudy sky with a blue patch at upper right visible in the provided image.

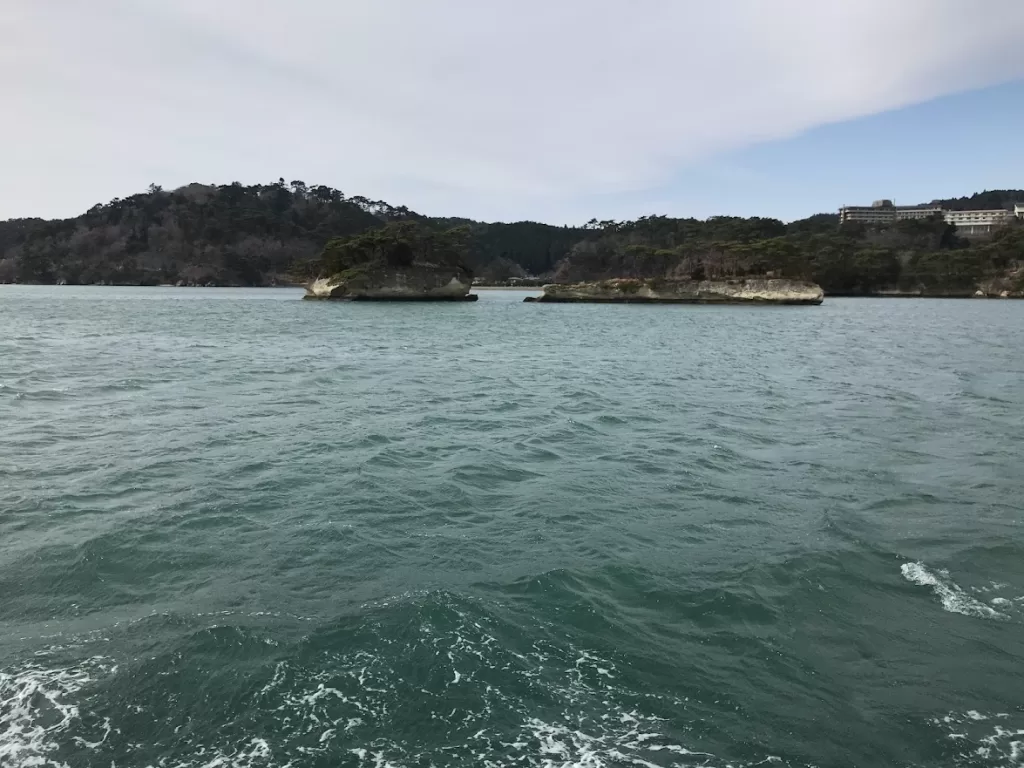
[0,0,1024,224]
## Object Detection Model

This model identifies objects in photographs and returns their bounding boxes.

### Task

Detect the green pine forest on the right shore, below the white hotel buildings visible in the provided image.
[553,216,1024,296]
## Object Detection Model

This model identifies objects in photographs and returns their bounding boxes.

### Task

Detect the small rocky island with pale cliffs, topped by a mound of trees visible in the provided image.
[303,221,477,301]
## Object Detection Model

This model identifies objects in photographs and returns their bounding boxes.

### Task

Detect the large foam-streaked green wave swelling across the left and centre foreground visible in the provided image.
[0,591,782,768]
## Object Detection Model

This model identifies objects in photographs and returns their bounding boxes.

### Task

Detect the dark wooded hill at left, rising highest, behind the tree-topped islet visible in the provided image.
[0,179,583,286]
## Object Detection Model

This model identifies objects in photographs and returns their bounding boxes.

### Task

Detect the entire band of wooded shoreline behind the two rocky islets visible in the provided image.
[0,179,1024,295]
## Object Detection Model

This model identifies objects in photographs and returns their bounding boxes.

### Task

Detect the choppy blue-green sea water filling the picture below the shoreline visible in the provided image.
[0,287,1024,768]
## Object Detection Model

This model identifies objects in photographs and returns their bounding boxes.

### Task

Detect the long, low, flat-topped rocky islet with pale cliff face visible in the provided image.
[525,278,824,304]
